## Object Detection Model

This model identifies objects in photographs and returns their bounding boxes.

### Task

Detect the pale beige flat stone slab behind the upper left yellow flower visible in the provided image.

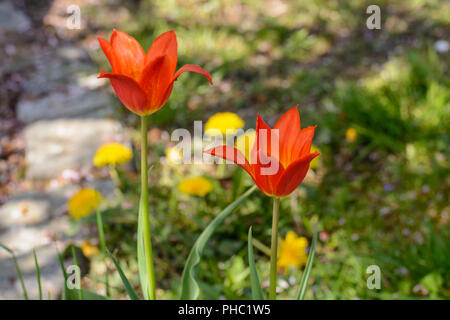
[24,119,122,179]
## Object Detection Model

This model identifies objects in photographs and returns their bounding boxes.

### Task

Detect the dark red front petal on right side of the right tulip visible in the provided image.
[275,152,319,197]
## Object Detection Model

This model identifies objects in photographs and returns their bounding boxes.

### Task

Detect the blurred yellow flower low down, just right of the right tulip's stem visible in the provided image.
[277,231,308,269]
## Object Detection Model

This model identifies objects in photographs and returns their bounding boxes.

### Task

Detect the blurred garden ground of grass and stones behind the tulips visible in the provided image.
[0,0,450,299]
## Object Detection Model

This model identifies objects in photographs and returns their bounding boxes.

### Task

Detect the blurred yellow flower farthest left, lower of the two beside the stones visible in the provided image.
[67,188,103,220]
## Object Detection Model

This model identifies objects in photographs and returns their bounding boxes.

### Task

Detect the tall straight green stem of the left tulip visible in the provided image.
[138,116,156,300]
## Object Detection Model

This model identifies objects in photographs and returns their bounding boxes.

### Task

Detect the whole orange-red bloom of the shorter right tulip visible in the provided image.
[205,106,319,197]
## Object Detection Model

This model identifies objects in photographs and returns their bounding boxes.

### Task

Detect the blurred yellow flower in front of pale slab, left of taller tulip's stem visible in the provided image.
[93,142,133,167]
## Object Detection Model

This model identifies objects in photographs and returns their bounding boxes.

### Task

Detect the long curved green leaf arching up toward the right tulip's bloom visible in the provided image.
[180,186,256,300]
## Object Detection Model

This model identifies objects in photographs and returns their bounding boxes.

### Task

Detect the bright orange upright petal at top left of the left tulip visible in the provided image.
[110,30,145,81]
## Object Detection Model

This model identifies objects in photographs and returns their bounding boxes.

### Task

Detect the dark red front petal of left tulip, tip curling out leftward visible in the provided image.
[98,71,147,115]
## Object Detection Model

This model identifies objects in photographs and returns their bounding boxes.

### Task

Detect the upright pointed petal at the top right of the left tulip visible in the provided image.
[145,30,178,75]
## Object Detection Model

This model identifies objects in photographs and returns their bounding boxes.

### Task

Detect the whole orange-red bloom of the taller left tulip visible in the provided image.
[98,30,212,115]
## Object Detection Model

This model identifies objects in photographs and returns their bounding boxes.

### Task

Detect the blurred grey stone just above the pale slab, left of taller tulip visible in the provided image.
[17,46,114,124]
